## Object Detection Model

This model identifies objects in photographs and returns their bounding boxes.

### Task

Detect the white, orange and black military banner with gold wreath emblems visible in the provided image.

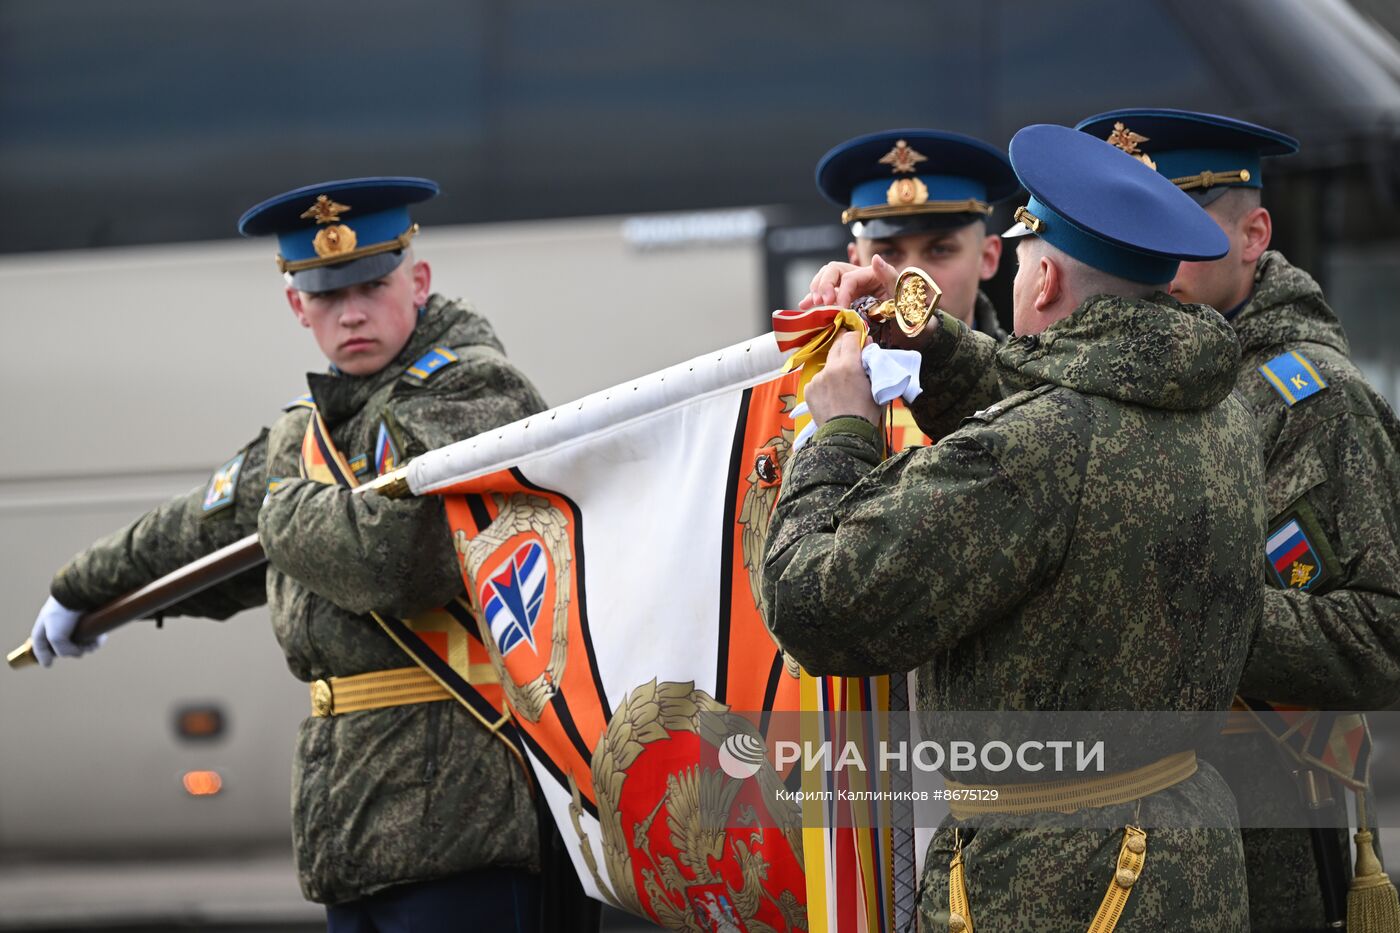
[394,315,918,930]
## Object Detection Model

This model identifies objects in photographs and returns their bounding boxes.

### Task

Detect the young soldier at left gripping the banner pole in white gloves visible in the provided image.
[32,179,554,933]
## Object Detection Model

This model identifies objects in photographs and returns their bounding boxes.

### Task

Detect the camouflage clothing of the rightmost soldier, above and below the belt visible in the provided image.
[1217,252,1400,930]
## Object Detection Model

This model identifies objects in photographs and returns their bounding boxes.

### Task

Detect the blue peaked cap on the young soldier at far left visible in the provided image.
[238,177,438,291]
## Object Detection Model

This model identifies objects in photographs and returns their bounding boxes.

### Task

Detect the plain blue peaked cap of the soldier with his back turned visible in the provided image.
[1004,123,1229,284]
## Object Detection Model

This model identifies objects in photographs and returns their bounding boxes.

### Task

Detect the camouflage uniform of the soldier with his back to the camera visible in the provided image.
[763,294,1266,930]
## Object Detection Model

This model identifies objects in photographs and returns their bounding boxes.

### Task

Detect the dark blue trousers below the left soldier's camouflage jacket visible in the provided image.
[326,869,540,933]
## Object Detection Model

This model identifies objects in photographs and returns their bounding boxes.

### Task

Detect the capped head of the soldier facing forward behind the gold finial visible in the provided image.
[816,129,1019,340]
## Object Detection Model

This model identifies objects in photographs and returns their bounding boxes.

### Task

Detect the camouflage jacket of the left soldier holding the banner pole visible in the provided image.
[52,296,543,904]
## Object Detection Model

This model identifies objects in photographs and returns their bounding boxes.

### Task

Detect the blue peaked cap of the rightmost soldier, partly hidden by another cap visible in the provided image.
[1075,108,1298,205]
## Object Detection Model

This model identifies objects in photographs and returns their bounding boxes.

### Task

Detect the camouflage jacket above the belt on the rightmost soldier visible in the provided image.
[1232,252,1400,709]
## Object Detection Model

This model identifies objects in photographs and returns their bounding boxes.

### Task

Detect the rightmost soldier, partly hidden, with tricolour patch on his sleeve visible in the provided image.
[1079,109,1400,930]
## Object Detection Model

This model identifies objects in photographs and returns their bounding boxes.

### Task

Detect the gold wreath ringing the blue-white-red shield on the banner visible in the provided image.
[454,493,574,723]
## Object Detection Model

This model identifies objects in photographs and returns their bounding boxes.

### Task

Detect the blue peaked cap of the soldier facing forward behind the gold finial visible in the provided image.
[816,129,1019,238]
